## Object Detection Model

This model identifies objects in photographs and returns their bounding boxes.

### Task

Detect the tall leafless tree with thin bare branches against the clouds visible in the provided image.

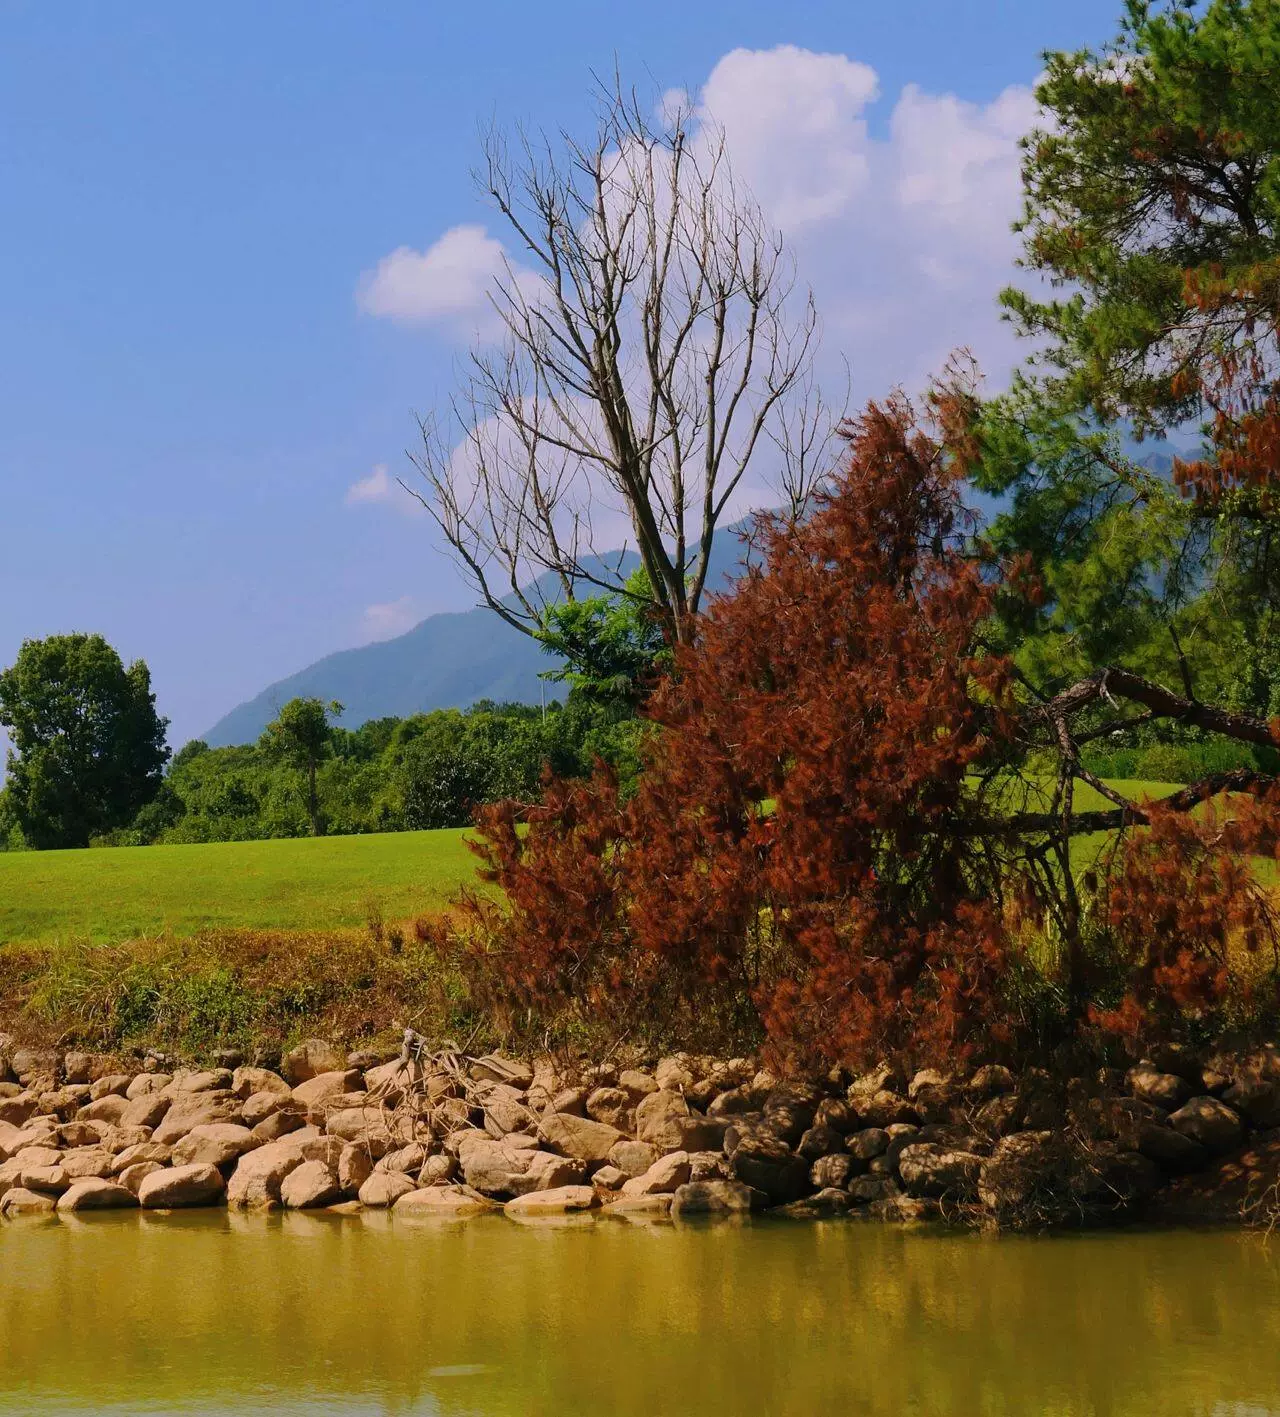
[410,85,839,640]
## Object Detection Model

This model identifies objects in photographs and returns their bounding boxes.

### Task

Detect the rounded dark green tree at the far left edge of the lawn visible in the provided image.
[0,635,169,847]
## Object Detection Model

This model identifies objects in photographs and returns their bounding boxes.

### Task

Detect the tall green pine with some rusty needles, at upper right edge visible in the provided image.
[975,0,1280,716]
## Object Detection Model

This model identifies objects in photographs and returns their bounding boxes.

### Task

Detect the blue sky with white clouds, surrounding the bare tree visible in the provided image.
[0,0,1117,745]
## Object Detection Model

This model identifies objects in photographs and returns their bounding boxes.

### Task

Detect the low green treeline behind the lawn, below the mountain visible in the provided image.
[0,701,642,850]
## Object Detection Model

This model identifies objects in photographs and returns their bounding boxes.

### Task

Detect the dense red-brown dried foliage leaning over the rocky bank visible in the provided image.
[436,398,1014,1061]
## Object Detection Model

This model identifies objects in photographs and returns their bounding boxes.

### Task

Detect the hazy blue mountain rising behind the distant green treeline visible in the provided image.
[201,527,741,748]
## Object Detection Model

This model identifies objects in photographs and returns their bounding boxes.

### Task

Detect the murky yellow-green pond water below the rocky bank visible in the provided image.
[0,1212,1280,1417]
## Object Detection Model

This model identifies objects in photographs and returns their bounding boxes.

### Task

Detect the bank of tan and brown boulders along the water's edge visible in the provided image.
[0,1034,1280,1227]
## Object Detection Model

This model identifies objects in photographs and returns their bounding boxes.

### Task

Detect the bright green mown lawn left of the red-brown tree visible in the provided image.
[0,830,475,944]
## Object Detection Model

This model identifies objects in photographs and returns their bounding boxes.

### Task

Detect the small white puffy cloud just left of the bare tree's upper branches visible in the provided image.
[356,225,506,326]
